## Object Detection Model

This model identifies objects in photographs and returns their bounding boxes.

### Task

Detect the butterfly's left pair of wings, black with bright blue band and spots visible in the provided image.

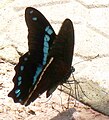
[8,7,56,104]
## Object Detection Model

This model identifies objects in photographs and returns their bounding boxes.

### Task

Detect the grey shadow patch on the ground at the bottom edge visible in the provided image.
[50,108,76,120]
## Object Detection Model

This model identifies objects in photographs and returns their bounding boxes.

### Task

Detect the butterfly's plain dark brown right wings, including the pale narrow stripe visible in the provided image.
[25,19,74,105]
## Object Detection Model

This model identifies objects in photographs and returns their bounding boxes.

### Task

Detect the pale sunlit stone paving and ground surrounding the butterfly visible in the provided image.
[0,0,109,120]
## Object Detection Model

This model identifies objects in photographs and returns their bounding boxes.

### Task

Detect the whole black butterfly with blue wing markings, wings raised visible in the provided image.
[8,7,74,106]
